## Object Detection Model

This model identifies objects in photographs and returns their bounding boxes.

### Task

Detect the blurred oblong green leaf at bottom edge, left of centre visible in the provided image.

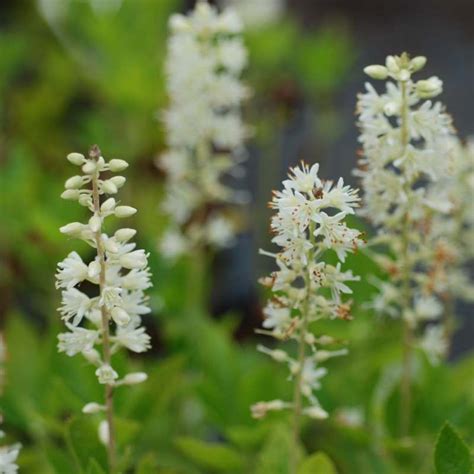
[176,437,244,472]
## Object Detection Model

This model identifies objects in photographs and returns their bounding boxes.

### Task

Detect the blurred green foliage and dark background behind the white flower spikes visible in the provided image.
[0,0,474,474]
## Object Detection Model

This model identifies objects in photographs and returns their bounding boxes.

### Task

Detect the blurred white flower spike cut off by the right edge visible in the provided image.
[420,140,474,363]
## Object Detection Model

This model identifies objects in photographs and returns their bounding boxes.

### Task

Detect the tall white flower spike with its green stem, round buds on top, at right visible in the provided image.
[356,53,454,435]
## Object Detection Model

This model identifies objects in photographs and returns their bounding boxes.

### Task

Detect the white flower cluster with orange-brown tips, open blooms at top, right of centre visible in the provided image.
[252,163,362,418]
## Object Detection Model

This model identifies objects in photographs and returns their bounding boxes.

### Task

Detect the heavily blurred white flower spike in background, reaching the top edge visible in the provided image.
[158,1,249,257]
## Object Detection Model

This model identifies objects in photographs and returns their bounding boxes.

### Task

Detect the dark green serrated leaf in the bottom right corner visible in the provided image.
[435,422,472,474]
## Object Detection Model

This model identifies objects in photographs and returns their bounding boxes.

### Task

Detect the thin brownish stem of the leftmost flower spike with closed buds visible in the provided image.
[90,147,117,474]
